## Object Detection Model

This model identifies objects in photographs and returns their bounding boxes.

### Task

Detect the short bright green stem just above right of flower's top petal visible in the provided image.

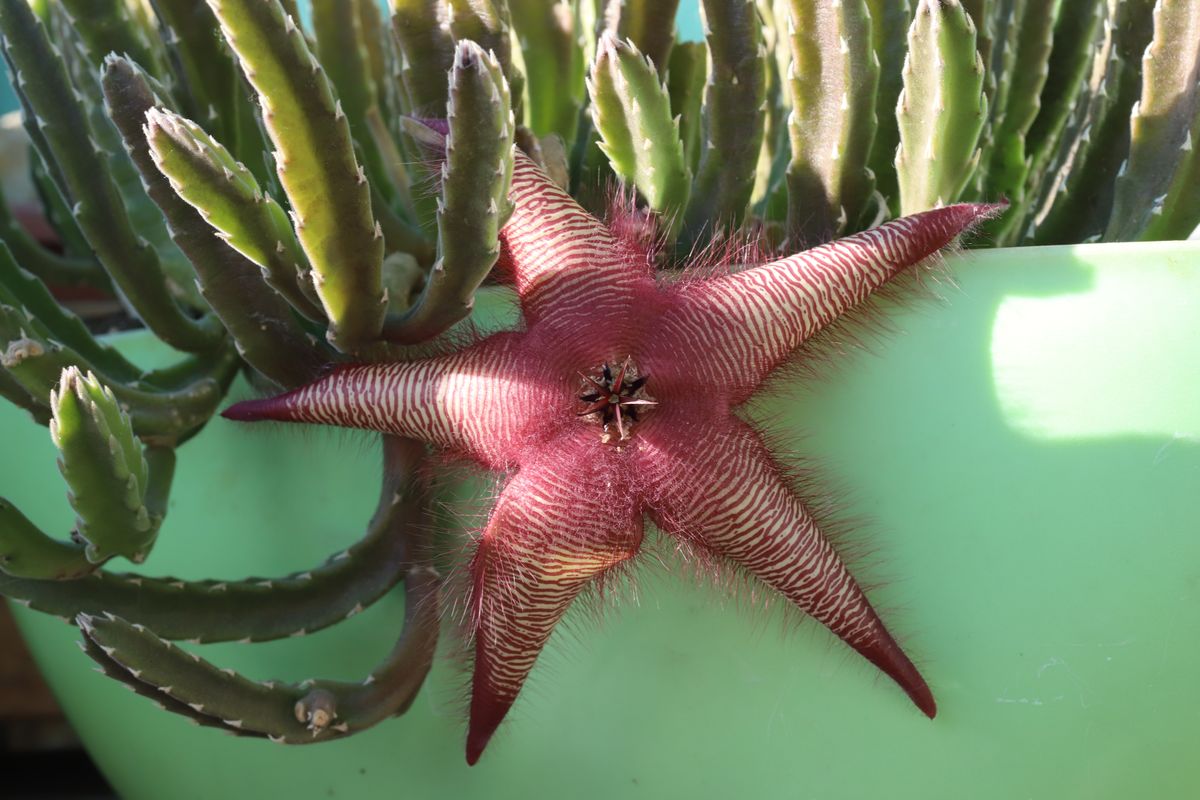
[588,34,691,240]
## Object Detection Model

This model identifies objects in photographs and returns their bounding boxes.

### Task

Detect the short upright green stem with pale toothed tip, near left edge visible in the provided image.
[50,367,165,564]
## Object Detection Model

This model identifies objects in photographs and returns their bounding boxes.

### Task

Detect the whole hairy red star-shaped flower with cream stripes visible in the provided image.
[226,146,997,764]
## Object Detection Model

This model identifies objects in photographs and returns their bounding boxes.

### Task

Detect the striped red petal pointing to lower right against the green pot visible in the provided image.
[634,417,937,717]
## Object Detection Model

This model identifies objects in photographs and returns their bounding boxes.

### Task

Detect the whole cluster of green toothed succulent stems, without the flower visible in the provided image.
[0,0,1200,762]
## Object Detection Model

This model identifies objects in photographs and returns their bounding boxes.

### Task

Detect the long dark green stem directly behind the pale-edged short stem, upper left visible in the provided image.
[104,56,322,387]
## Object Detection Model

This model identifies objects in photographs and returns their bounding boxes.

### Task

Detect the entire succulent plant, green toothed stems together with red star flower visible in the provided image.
[0,0,1200,760]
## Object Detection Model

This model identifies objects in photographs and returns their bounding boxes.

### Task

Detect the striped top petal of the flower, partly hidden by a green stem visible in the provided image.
[500,151,654,366]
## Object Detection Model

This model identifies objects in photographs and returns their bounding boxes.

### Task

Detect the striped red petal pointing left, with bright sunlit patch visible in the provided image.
[222,333,559,470]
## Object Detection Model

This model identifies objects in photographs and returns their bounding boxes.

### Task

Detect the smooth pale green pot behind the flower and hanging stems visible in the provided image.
[0,245,1200,800]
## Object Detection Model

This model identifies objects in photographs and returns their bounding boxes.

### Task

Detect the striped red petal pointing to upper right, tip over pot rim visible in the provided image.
[648,204,1004,404]
